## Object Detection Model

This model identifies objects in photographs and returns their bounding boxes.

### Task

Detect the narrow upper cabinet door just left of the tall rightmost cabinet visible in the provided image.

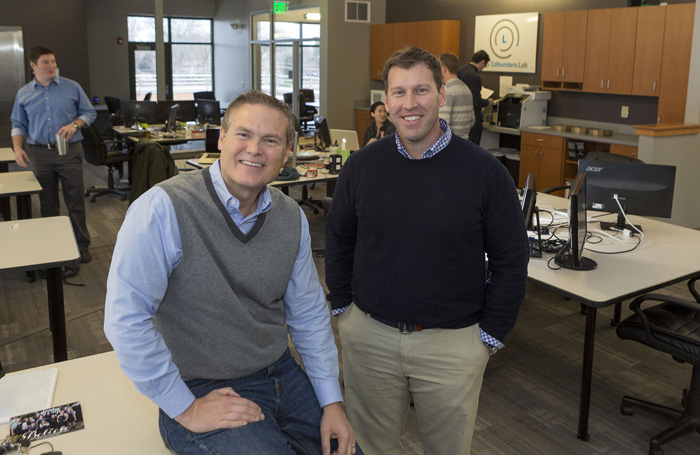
[632,6,666,96]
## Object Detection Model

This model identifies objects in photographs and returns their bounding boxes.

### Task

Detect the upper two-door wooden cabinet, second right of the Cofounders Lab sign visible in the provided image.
[583,8,639,95]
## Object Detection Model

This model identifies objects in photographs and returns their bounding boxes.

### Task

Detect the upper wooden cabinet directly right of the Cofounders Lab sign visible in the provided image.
[542,11,588,90]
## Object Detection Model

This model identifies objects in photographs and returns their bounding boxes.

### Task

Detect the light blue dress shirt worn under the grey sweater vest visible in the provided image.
[105,161,342,418]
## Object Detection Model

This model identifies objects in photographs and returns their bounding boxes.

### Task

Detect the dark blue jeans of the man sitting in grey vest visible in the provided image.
[159,350,362,455]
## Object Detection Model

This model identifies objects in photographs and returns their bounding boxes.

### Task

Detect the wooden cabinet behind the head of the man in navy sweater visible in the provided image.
[369,20,459,80]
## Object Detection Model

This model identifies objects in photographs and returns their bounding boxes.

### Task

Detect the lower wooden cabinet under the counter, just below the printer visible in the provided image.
[518,132,564,189]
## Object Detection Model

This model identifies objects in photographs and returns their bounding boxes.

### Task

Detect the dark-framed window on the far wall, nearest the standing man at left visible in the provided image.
[127,16,214,100]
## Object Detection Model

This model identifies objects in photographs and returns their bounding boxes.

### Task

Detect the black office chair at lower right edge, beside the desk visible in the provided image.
[617,277,700,455]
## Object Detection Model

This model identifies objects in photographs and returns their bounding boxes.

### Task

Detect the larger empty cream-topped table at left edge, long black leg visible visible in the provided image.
[0,216,80,362]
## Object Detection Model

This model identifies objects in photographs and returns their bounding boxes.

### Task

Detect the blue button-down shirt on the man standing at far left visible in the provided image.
[10,75,97,144]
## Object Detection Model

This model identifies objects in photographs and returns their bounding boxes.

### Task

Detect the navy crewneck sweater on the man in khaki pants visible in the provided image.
[326,135,529,341]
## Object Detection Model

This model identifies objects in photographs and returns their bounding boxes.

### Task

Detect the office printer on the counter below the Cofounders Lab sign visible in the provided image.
[496,86,552,129]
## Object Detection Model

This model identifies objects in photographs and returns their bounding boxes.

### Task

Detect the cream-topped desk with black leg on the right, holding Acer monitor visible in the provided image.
[528,194,700,441]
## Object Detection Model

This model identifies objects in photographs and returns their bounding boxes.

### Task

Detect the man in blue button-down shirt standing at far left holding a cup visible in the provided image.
[12,46,97,262]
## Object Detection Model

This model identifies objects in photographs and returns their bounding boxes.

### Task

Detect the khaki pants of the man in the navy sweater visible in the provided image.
[338,305,489,455]
